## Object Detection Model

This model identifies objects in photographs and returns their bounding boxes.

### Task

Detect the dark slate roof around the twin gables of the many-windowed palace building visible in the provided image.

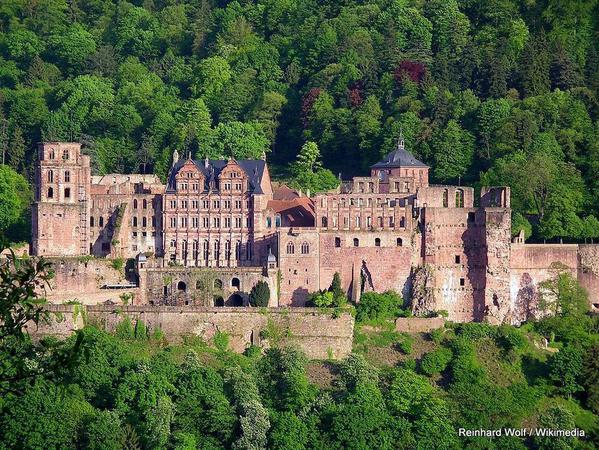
[166,159,266,194]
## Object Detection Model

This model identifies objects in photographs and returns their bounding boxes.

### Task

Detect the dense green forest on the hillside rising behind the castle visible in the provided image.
[0,0,599,241]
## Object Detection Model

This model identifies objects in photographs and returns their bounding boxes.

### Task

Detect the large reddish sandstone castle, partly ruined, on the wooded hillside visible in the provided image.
[32,138,599,323]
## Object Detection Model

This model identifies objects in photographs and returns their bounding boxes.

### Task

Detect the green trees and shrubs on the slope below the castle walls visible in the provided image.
[0,246,599,450]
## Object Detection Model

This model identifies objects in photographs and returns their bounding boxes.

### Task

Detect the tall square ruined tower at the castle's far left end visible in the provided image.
[31,142,91,256]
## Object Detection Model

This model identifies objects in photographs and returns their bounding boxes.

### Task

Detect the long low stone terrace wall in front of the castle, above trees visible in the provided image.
[29,305,354,359]
